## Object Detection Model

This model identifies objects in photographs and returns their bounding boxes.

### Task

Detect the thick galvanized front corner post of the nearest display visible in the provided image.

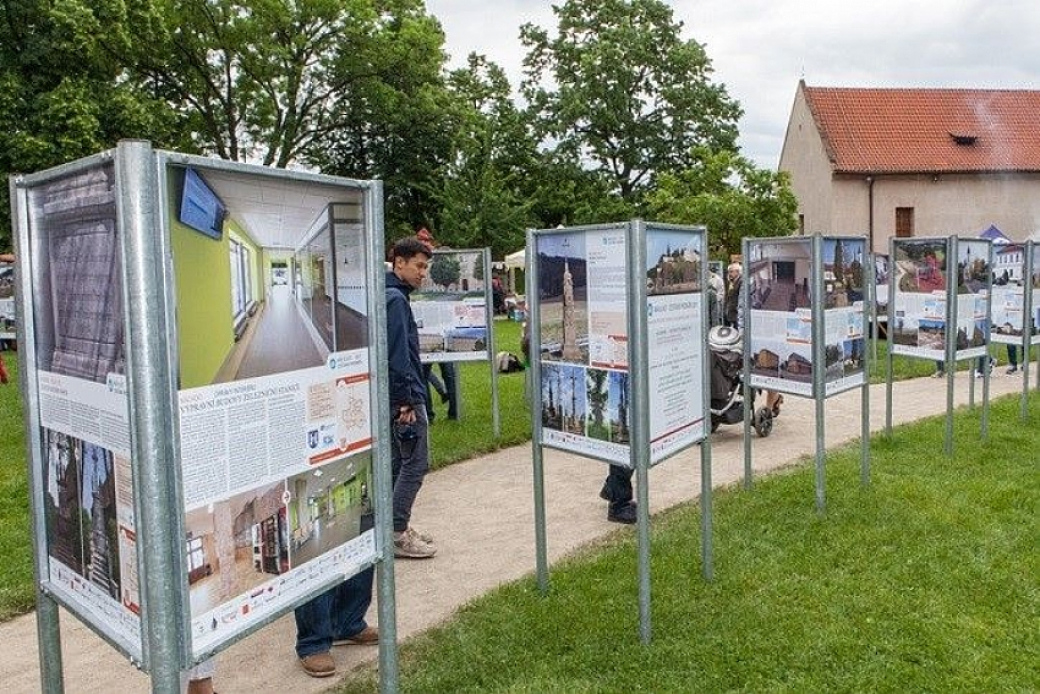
[115,140,189,694]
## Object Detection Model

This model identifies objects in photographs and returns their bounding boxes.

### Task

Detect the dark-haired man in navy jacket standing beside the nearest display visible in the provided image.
[386,237,437,559]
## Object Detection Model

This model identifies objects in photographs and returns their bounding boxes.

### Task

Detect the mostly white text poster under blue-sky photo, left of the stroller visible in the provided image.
[646,227,705,462]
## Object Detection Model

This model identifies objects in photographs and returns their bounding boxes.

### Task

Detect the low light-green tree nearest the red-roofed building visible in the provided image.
[647,148,798,258]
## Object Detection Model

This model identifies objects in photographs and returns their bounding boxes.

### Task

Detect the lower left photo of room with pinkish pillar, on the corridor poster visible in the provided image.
[184,483,289,617]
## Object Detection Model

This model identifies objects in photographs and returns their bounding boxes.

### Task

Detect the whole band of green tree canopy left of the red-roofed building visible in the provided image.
[0,0,795,257]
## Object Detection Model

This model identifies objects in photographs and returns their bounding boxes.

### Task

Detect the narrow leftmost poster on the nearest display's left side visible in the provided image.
[27,163,141,654]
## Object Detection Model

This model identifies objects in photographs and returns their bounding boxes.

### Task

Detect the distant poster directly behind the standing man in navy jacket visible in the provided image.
[412,249,491,362]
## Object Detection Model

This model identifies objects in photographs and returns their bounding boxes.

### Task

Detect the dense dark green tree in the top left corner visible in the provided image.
[0,0,186,251]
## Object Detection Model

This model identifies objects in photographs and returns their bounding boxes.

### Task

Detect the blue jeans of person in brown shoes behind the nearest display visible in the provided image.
[295,515,375,658]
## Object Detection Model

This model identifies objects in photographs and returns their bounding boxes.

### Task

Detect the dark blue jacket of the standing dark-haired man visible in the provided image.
[387,273,426,413]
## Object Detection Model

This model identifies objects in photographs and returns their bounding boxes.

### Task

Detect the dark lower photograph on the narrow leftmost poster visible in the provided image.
[43,429,122,600]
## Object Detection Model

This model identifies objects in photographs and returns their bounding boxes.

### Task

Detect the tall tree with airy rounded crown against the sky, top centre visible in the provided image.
[521,0,742,202]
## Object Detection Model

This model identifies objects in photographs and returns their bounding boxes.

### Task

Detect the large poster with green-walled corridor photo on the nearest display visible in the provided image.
[166,165,375,657]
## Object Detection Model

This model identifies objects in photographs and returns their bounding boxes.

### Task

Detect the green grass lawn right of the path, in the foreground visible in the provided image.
[342,395,1040,693]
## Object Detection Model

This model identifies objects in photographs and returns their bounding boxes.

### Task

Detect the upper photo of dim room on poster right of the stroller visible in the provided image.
[748,238,812,312]
